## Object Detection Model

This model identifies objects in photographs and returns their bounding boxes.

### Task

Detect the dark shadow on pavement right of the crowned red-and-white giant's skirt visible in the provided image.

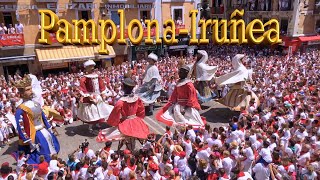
[201,108,240,123]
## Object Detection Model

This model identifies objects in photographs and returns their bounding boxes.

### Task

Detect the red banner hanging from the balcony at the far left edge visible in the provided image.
[0,34,24,47]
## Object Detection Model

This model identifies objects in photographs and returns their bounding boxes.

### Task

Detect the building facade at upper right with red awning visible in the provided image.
[208,0,320,52]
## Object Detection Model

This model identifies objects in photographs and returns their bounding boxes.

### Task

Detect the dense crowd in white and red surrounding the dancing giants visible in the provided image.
[0,45,320,180]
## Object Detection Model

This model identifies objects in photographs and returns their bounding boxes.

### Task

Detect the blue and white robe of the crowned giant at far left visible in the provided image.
[15,100,60,164]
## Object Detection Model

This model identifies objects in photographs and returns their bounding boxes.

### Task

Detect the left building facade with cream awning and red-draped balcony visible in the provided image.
[0,0,159,75]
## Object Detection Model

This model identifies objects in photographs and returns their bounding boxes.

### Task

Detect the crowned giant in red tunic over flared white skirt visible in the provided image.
[156,65,206,128]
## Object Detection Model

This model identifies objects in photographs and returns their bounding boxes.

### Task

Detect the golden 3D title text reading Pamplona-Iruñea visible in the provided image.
[39,9,282,54]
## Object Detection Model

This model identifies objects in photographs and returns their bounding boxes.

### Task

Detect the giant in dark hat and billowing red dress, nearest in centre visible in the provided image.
[96,78,149,150]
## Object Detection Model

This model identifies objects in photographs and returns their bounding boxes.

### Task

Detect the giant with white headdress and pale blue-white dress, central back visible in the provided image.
[135,53,163,115]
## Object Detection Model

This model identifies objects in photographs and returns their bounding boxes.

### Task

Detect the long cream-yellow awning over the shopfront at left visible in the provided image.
[36,45,115,62]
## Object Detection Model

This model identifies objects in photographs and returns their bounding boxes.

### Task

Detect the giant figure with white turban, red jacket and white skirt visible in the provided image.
[77,60,113,131]
